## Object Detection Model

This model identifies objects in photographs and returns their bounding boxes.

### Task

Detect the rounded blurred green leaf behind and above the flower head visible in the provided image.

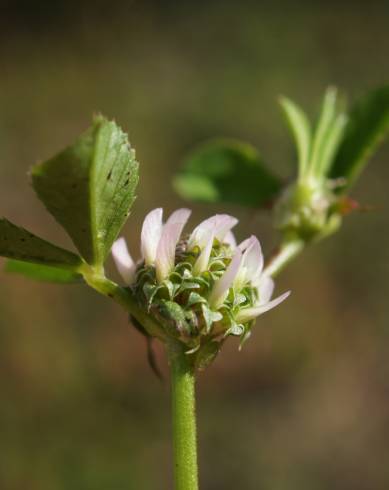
[173,139,282,207]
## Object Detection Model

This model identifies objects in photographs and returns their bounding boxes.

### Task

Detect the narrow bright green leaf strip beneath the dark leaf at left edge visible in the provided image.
[4,260,82,284]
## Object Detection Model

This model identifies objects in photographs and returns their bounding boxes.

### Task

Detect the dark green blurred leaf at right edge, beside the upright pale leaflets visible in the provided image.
[330,86,389,188]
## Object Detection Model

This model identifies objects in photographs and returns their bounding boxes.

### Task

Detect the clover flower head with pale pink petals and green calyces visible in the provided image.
[112,208,289,366]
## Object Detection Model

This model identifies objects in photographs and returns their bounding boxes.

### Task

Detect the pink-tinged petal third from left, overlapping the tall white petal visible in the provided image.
[155,223,182,282]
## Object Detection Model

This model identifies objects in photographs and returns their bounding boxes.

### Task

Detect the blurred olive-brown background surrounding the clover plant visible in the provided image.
[0,0,389,490]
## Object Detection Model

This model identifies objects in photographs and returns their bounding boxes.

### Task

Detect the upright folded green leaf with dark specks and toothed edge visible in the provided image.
[32,116,138,266]
